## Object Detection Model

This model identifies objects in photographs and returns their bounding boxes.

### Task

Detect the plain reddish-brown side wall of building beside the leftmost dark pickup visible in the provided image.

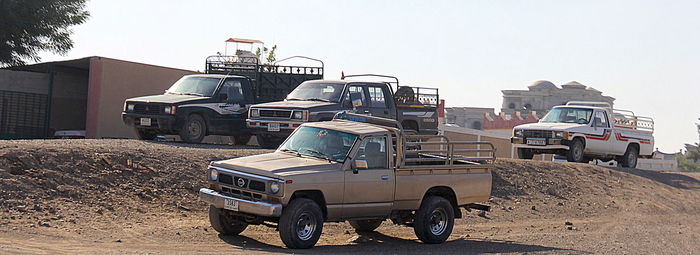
[86,57,195,138]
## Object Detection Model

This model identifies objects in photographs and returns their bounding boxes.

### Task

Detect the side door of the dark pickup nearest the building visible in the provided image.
[212,79,247,134]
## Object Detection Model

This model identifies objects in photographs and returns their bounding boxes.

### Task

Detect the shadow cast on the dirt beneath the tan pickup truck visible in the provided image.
[219,232,585,254]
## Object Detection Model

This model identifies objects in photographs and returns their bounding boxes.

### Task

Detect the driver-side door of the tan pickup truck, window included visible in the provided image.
[343,136,395,218]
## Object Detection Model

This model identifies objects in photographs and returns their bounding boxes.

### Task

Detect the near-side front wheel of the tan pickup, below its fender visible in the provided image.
[278,198,323,249]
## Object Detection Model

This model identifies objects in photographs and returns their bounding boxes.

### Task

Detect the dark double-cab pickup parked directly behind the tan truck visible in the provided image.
[247,74,440,148]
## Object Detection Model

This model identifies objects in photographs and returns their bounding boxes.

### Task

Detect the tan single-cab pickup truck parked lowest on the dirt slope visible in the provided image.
[199,112,494,248]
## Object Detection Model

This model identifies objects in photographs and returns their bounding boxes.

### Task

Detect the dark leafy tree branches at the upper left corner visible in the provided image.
[0,0,90,66]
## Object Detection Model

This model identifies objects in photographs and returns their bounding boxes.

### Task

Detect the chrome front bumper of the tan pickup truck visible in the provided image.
[199,188,282,217]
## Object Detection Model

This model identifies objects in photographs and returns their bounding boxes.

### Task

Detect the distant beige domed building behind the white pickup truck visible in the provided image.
[501,80,615,118]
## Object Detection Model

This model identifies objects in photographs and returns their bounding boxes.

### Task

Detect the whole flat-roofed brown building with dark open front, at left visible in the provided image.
[0,57,195,139]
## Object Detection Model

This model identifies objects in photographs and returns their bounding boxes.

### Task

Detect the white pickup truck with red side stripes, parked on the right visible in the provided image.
[511,101,654,168]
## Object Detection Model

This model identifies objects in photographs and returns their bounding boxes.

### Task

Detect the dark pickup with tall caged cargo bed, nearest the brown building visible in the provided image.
[122,56,323,144]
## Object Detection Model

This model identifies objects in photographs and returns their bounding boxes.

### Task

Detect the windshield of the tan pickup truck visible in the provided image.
[280,127,357,163]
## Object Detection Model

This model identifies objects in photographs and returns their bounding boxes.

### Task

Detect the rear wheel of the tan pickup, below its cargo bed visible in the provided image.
[413,196,455,244]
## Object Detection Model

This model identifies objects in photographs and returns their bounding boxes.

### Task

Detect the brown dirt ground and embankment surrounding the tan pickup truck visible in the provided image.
[0,140,700,254]
